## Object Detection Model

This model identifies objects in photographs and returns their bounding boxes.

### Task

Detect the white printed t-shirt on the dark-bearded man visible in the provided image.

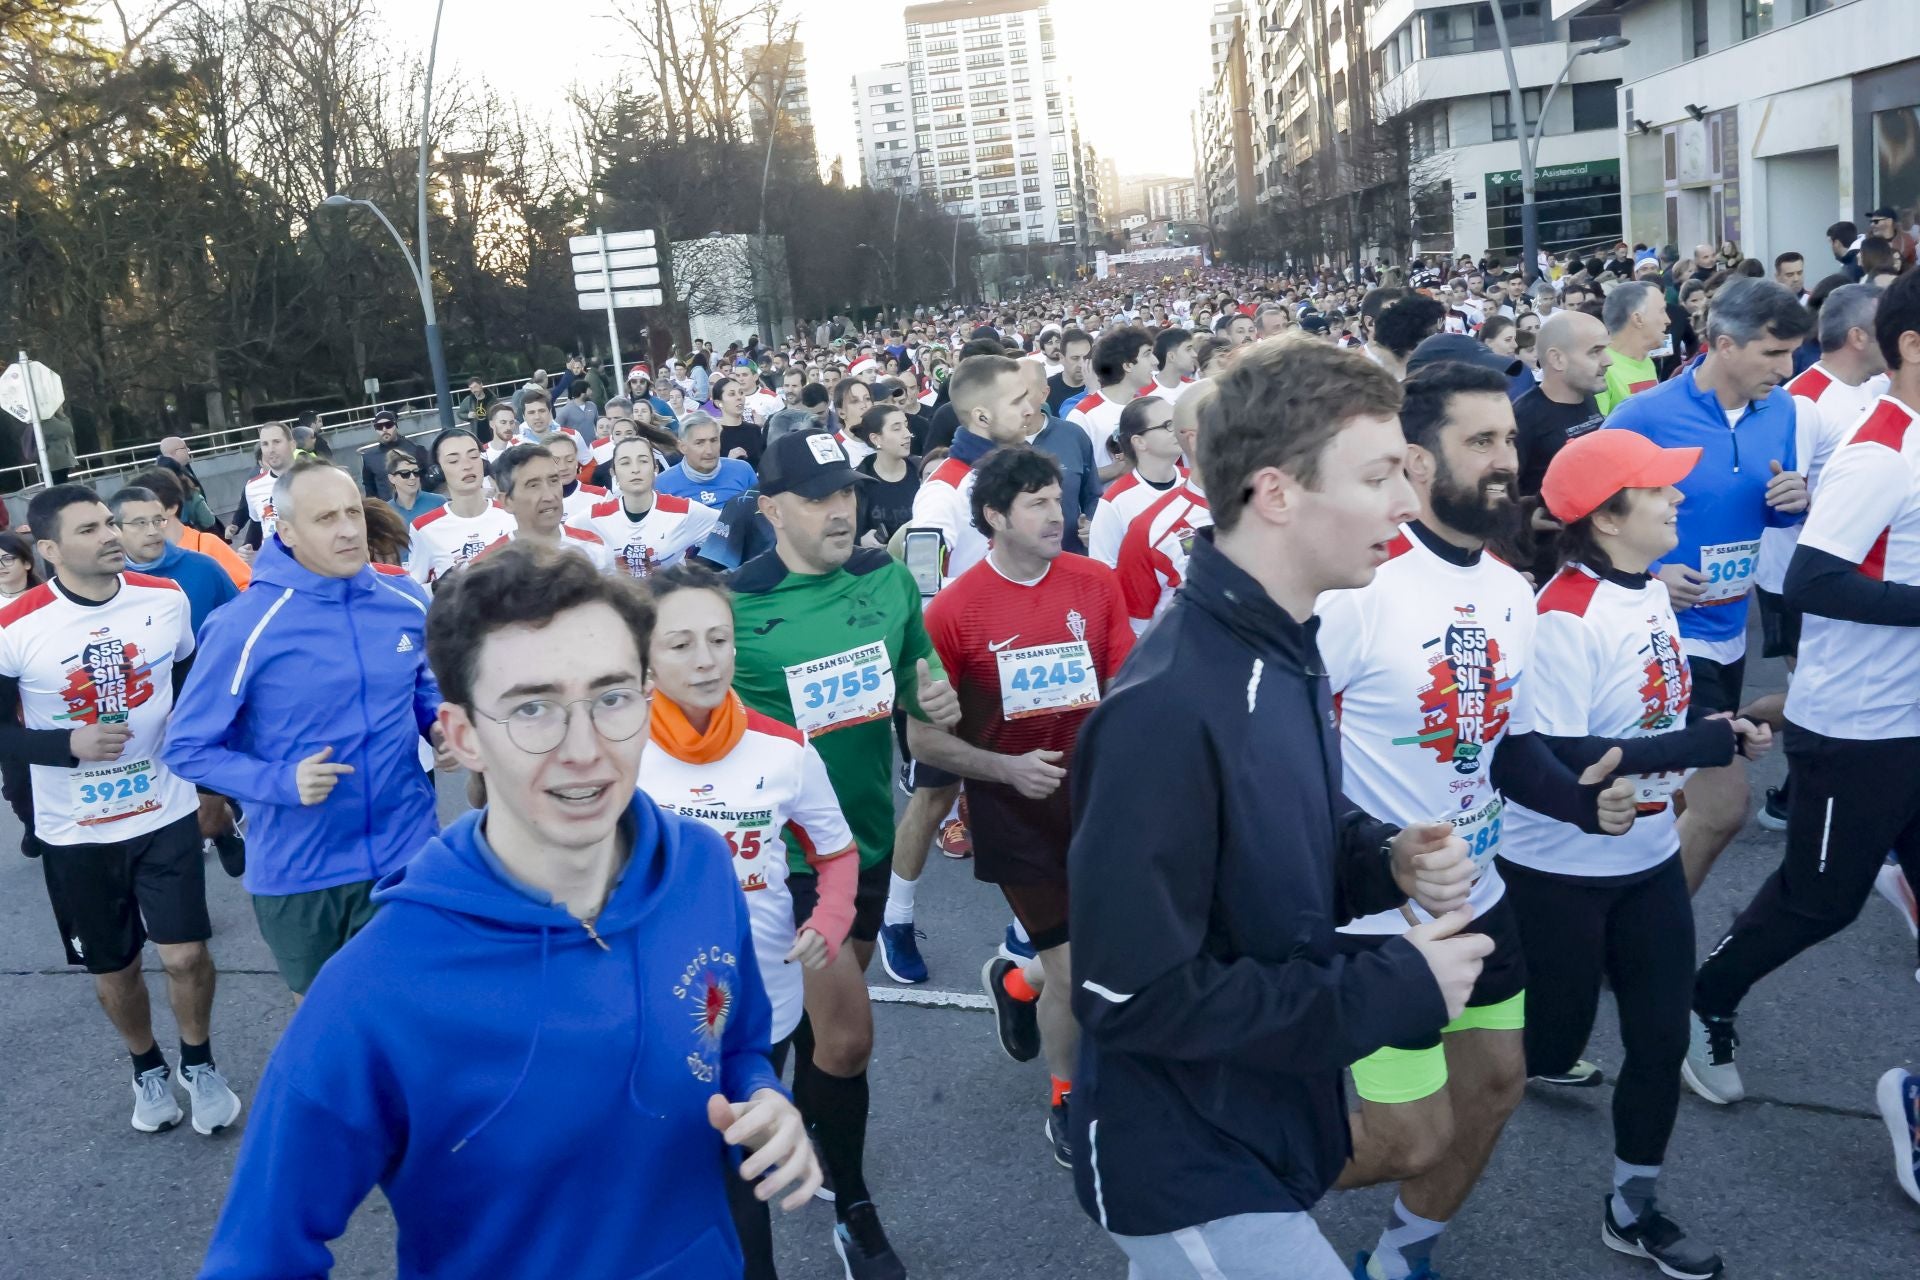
[1315,526,1534,933]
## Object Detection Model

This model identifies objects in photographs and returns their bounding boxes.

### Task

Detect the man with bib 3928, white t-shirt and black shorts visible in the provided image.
[0,484,240,1134]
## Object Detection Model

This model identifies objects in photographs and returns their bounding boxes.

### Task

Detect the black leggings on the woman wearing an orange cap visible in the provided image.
[1500,854,1693,1165]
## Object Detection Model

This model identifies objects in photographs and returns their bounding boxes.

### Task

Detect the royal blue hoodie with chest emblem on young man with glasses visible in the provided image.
[200,793,780,1280]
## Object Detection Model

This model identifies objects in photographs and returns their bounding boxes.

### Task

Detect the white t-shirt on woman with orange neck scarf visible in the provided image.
[639,710,860,1042]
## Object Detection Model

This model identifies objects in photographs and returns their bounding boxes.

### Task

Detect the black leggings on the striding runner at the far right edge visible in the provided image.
[1693,723,1920,1017]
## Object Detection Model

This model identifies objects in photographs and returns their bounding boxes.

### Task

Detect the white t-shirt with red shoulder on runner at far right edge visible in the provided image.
[1786,395,1920,740]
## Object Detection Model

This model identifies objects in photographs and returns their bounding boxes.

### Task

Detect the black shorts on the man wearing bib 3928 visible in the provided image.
[40,814,213,973]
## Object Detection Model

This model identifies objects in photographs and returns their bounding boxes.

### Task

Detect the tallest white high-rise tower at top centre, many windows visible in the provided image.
[906,0,1091,249]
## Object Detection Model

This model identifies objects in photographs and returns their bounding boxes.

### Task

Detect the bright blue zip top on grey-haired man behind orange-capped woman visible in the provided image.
[1607,367,1801,643]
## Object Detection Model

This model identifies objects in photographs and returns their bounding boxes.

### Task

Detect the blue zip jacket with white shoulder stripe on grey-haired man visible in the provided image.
[161,535,440,896]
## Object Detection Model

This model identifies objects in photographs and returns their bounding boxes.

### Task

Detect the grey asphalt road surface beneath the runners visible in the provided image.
[0,664,1920,1280]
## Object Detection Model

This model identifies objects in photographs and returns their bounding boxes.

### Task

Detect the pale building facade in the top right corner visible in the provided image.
[1551,0,1920,270]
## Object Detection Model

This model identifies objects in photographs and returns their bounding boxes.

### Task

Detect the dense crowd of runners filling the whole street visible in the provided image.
[0,228,1920,1280]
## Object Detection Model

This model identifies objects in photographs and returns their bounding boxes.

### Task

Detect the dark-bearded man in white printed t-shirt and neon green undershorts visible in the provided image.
[1319,361,1634,1280]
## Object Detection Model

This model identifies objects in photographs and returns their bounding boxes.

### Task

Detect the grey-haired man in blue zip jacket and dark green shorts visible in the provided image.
[165,462,449,996]
